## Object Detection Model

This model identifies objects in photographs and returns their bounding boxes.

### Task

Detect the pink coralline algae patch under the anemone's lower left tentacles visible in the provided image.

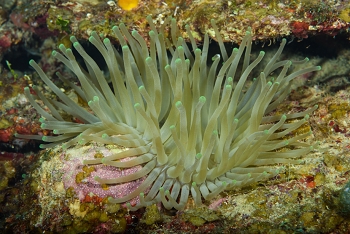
[61,146,144,205]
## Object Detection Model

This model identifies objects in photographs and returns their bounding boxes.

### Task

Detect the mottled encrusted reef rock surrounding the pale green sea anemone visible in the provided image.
[0,0,350,233]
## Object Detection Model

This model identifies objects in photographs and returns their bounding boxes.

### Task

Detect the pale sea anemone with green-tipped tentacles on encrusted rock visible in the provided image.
[17,17,320,210]
